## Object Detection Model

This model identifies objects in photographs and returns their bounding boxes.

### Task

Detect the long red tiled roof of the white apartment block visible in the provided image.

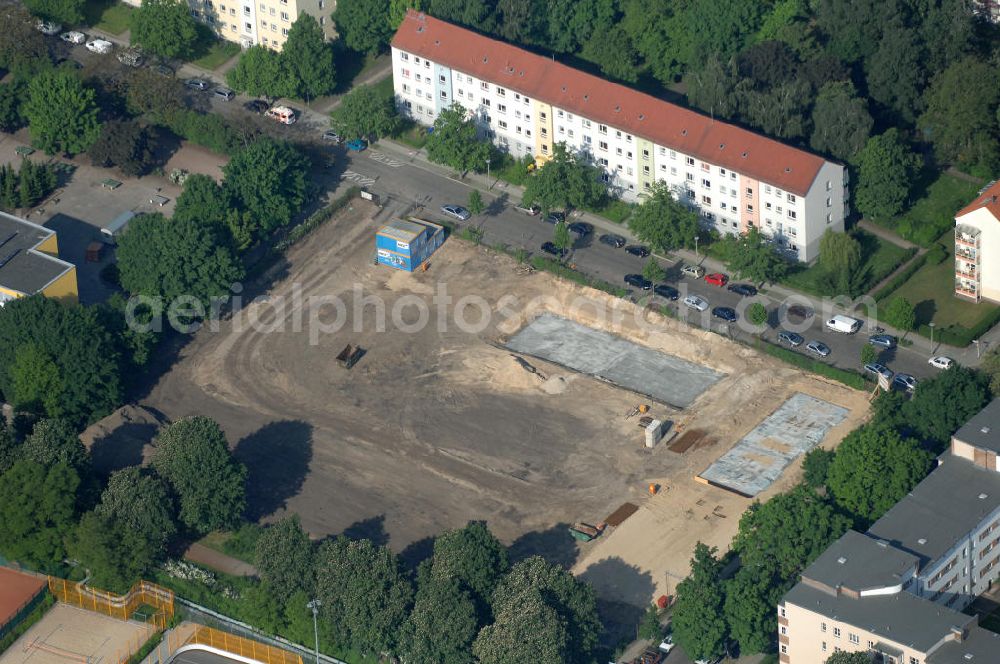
[392,9,824,196]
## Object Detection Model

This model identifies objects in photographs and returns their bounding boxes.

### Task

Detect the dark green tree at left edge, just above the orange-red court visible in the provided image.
[0,460,80,569]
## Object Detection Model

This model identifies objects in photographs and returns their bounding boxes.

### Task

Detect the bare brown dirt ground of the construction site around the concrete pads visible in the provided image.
[142,201,867,601]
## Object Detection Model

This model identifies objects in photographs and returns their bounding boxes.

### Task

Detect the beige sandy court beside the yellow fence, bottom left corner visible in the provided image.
[0,604,153,664]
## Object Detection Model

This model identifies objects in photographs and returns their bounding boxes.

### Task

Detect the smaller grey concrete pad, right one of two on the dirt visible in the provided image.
[700,392,849,497]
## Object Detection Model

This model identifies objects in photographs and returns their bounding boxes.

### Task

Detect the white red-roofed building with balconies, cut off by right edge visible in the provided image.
[955,182,1000,302]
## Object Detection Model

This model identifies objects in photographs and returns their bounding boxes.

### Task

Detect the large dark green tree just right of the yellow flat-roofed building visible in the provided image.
[117,214,243,306]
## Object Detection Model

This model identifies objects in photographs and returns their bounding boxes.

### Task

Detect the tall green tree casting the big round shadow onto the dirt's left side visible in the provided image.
[153,417,247,533]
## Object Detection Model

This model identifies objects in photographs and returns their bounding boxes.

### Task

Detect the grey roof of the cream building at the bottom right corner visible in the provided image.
[785,583,976,652]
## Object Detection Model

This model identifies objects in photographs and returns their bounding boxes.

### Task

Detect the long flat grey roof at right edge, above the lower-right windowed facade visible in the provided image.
[868,454,1000,564]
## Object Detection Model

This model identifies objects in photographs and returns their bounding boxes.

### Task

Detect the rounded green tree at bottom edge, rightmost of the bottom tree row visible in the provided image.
[472,590,578,664]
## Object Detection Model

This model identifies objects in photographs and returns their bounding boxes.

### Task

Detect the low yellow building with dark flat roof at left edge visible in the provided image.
[0,212,78,306]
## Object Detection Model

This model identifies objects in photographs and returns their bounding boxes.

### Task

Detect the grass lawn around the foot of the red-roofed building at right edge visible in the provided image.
[883,238,996,330]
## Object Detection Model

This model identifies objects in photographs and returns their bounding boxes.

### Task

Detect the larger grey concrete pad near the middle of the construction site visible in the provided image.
[506,314,723,408]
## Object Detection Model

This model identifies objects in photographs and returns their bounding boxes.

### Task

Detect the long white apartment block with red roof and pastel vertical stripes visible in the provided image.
[392,10,848,261]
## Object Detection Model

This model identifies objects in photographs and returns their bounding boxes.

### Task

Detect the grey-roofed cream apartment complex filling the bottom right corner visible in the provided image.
[778,399,1000,664]
